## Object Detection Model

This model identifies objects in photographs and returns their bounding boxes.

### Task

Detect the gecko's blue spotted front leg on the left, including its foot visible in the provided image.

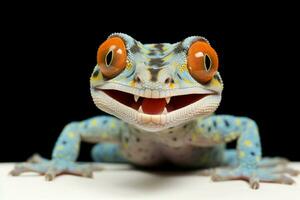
[10,116,124,180]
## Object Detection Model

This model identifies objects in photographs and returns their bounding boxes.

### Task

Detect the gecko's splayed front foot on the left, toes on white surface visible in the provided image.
[10,159,102,181]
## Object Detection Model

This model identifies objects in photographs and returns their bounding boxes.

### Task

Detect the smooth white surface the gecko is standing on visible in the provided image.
[0,163,300,200]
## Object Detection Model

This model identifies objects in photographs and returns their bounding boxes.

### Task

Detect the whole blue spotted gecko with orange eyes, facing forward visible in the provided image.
[11,33,299,189]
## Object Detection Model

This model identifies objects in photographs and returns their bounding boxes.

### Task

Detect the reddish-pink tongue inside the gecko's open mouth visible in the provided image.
[142,98,166,115]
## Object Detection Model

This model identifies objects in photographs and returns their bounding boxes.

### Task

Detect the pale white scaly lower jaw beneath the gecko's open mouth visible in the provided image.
[91,89,221,130]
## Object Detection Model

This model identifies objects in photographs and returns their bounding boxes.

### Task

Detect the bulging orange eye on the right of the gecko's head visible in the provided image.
[188,41,219,84]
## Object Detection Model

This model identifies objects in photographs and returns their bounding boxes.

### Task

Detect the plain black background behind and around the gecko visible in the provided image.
[0,3,300,162]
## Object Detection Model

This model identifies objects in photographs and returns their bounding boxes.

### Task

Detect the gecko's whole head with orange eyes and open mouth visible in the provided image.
[90,33,223,132]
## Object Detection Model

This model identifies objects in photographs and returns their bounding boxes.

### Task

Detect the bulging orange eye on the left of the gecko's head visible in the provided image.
[97,37,127,79]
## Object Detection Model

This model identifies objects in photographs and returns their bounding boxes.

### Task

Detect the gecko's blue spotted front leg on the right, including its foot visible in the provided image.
[191,115,293,189]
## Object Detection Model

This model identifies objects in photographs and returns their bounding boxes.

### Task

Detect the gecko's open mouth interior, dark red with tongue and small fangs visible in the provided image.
[96,89,211,115]
